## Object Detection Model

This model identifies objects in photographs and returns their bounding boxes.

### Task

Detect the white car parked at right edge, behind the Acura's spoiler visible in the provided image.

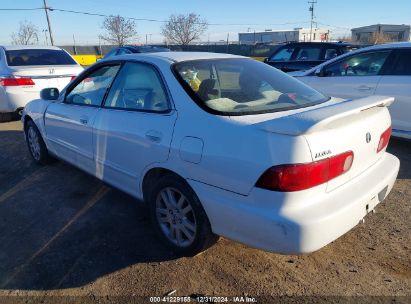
[293,42,411,139]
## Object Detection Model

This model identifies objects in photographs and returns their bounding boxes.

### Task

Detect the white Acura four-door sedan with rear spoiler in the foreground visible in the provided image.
[22,52,399,255]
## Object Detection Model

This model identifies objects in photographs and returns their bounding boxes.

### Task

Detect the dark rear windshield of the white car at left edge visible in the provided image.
[6,49,77,66]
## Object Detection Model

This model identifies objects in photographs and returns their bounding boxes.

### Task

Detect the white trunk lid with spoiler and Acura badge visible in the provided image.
[257,96,394,191]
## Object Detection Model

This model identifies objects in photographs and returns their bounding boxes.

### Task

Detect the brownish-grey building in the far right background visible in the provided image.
[351,24,410,43]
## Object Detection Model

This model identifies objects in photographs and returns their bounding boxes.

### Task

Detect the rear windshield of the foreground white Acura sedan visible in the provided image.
[173,59,329,115]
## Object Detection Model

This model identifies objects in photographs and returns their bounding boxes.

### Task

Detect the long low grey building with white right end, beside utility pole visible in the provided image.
[238,28,330,44]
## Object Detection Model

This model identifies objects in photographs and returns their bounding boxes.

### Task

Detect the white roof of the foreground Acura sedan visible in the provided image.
[109,52,248,62]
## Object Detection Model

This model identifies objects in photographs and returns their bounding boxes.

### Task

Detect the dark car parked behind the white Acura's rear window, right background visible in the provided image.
[264,42,360,72]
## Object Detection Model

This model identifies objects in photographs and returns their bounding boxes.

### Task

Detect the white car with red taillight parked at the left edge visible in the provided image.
[0,45,83,122]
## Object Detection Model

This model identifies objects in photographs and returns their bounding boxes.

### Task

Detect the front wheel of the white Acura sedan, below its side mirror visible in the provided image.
[24,120,51,165]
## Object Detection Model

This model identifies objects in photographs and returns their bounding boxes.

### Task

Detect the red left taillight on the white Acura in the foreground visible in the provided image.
[256,151,354,192]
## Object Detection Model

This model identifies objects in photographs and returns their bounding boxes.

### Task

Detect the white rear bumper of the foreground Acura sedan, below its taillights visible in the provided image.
[189,153,400,254]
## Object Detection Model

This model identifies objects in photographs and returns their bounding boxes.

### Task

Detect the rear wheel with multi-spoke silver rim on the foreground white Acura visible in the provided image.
[147,174,219,256]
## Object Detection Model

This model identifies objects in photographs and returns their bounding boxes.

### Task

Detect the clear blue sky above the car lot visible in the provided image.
[0,0,411,45]
